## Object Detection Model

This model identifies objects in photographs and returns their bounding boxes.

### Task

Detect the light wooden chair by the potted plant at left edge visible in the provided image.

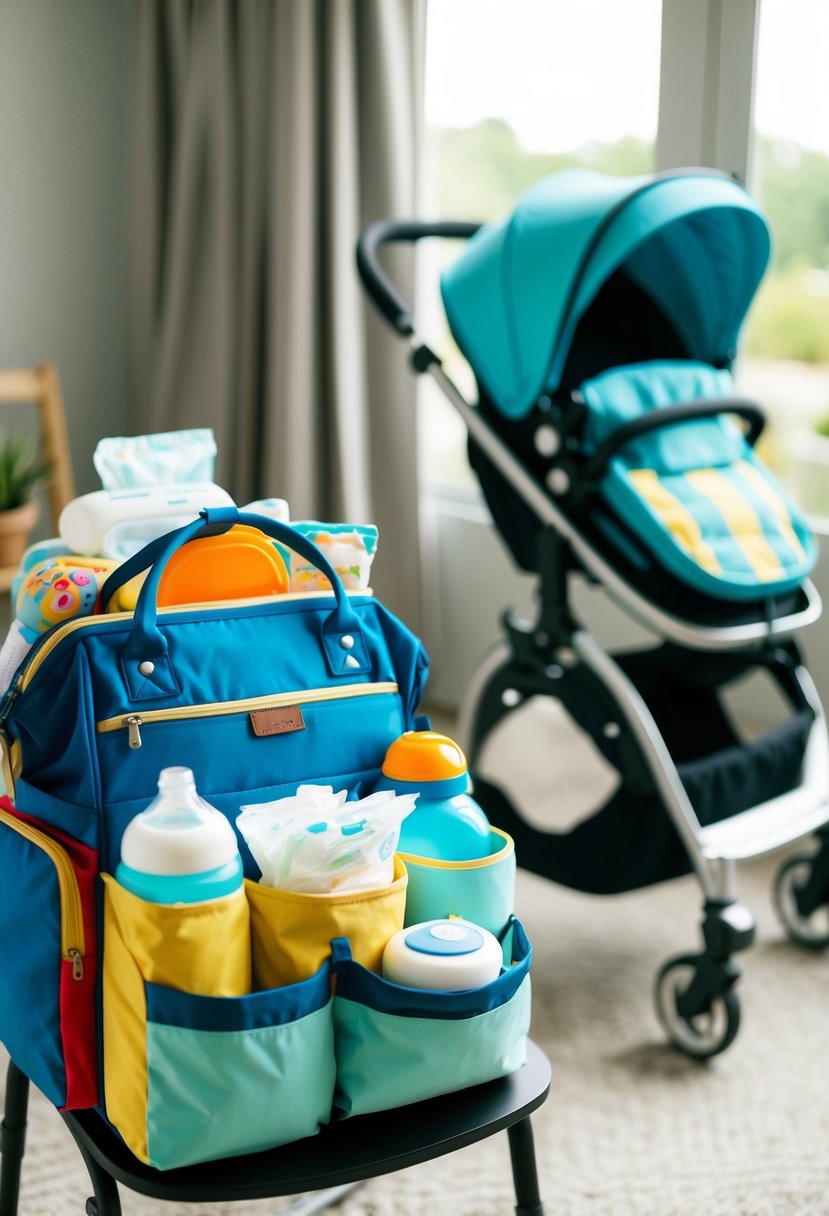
[0,364,75,591]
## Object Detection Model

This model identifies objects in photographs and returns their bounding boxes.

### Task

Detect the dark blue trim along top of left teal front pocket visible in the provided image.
[145,963,331,1031]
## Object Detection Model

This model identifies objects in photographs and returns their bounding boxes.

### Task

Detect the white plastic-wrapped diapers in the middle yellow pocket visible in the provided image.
[236,786,417,895]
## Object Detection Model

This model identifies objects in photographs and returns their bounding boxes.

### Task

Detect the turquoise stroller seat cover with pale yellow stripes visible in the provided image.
[571,361,817,602]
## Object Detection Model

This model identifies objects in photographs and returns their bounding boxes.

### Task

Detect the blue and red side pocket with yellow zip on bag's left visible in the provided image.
[0,798,98,1110]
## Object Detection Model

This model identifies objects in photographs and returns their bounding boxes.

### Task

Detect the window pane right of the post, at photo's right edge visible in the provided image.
[739,0,829,516]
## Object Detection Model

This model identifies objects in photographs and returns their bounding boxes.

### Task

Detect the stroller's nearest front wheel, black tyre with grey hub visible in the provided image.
[655,955,740,1059]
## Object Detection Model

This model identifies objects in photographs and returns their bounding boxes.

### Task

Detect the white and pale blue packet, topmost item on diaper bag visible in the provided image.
[92,427,216,490]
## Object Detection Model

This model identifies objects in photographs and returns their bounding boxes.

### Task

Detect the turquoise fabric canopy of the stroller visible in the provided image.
[441,169,769,418]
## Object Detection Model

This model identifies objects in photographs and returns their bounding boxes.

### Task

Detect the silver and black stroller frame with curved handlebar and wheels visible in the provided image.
[357,220,829,1058]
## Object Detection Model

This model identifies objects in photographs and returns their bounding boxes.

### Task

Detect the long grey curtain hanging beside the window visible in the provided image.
[129,0,423,627]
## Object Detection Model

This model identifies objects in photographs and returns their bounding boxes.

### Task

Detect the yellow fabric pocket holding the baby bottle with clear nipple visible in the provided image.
[102,874,250,1161]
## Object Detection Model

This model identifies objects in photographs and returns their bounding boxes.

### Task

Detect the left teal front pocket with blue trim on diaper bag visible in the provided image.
[145,964,335,1170]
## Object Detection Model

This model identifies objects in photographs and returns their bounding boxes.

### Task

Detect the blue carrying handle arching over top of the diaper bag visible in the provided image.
[101,507,371,700]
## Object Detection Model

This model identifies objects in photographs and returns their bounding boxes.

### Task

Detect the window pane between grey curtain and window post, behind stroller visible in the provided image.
[418,0,661,490]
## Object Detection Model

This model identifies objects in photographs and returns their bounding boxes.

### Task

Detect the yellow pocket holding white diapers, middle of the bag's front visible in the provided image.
[246,856,408,990]
